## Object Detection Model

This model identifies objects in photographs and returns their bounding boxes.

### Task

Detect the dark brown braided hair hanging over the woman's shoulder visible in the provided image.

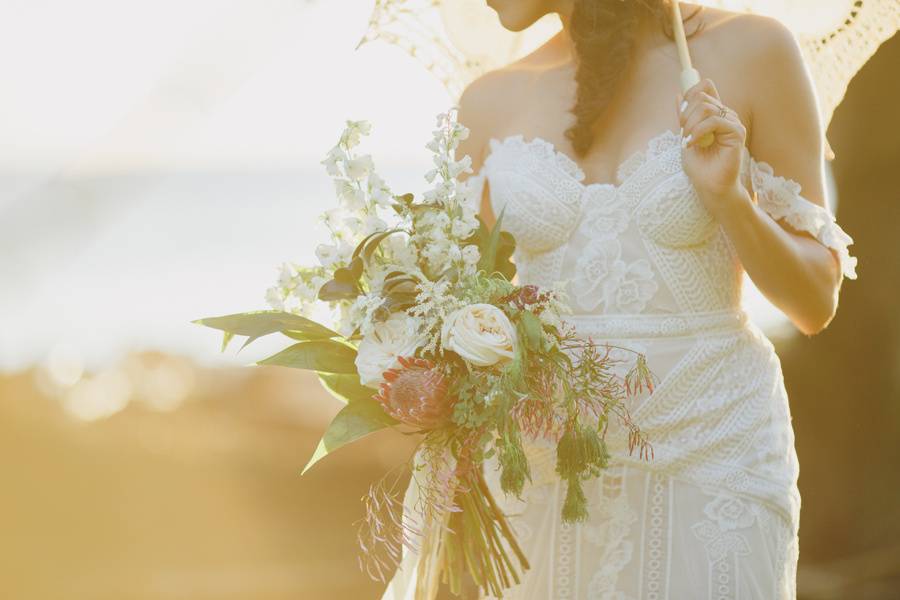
[566,0,702,157]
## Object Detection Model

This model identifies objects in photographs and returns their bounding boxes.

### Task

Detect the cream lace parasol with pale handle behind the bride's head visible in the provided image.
[360,0,900,152]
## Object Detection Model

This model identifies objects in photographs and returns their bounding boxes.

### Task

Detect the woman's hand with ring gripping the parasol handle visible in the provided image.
[678,79,747,220]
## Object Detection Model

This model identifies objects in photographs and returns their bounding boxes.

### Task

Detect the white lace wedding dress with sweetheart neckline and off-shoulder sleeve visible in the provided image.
[383,131,856,600]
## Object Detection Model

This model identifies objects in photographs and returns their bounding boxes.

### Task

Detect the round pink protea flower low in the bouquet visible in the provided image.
[375,356,454,429]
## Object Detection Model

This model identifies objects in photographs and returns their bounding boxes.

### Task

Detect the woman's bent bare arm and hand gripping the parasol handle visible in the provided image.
[681,17,842,335]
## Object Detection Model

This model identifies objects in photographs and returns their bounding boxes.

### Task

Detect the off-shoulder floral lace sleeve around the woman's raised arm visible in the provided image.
[749,156,856,279]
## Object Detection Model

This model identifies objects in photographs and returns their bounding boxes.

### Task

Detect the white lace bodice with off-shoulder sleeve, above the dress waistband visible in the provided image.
[470,131,856,316]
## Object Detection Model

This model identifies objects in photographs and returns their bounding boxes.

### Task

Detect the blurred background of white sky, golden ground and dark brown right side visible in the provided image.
[0,0,900,600]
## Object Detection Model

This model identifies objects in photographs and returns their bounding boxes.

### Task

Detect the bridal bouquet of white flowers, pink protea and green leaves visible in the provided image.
[197,110,653,598]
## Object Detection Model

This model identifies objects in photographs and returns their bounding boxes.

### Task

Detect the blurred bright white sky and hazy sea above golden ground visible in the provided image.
[0,0,785,369]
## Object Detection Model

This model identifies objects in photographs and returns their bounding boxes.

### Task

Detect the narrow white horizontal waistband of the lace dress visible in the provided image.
[563,308,748,339]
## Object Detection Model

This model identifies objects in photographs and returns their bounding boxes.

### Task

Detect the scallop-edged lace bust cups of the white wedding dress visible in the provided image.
[485,130,740,253]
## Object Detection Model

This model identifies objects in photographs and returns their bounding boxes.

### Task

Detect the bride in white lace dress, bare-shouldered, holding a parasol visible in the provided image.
[384,0,856,600]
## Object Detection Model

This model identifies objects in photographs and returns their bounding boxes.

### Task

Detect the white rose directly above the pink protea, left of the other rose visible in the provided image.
[356,312,427,388]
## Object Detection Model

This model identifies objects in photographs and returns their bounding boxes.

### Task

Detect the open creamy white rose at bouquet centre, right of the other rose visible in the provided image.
[441,304,516,367]
